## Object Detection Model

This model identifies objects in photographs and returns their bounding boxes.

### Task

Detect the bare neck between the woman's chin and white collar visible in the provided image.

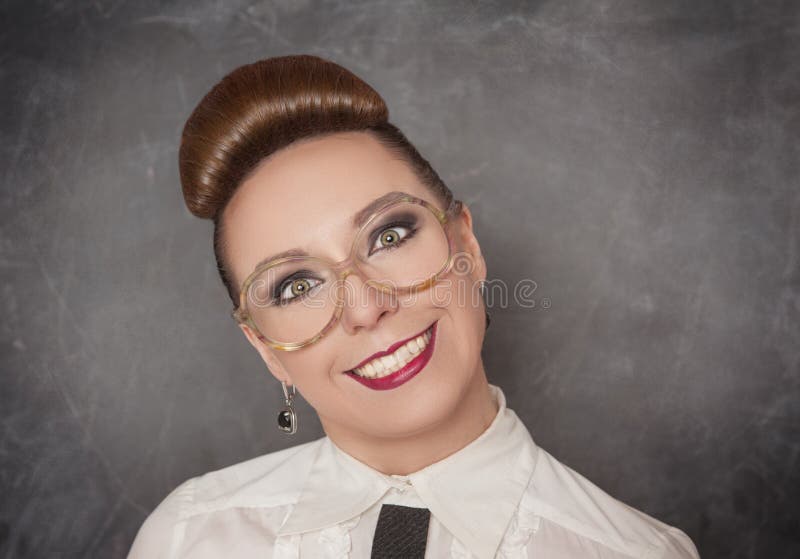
[323,364,498,475]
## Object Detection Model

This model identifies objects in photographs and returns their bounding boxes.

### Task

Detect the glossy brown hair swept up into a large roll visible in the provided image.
[179,55,453,308]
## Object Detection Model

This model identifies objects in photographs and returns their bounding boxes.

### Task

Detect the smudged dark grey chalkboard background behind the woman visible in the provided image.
[0,0,800,559]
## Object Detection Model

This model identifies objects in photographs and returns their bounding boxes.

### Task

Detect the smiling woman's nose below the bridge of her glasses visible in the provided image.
[340,273,398,334]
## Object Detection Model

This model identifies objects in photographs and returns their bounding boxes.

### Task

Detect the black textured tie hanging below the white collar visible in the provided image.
[371,505,431,559]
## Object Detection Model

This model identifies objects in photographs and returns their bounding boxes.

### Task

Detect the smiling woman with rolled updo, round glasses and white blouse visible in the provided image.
[130,56,697,559]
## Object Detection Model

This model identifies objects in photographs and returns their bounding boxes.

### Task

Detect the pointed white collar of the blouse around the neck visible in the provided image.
[278,384,537,559]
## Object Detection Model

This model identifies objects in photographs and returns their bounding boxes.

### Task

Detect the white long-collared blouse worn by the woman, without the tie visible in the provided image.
[128,385,699,559]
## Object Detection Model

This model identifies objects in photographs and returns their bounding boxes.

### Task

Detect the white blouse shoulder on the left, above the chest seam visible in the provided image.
[128,438,325,559]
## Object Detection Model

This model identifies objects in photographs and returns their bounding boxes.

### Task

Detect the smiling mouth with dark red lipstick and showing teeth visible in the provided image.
[345,321,438,390]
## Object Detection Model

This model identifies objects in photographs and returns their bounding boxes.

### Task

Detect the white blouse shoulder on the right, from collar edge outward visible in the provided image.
[520,447,699,559]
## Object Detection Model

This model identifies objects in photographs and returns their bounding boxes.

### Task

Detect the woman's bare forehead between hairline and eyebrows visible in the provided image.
[224,132,440,281]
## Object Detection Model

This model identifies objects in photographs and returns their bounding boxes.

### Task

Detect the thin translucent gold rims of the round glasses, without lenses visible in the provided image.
[231,194,463,351]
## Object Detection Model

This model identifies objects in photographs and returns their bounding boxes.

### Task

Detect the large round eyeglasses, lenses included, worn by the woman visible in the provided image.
[232,194,462,351]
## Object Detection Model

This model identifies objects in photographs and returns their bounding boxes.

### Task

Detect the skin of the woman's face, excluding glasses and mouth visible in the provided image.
[224,132,486,438]
